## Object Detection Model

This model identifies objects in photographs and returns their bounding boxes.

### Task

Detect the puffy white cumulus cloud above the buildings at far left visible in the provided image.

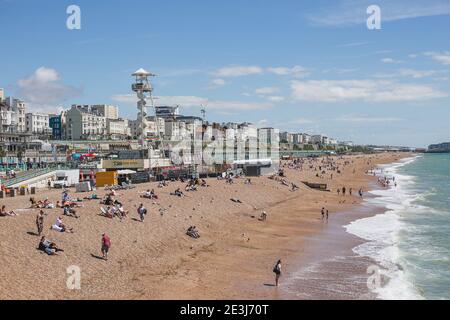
[17,67,81,112]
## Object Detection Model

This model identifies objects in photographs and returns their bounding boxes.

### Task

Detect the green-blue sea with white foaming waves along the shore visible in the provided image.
[345,153,450,300]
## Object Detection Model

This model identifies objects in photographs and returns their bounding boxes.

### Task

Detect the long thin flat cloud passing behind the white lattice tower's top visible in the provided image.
[111,94,273,110]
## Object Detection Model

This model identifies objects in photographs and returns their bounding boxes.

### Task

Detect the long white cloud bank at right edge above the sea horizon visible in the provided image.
[291,80,448,102]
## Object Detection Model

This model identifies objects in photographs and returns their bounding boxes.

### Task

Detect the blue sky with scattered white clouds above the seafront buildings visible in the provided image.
[0,0,450,146]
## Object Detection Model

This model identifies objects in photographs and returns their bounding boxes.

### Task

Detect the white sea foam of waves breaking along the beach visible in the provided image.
[345,157,423,300]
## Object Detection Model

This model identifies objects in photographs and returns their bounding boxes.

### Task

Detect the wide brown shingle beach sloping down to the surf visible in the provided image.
[0,153,410,299]
